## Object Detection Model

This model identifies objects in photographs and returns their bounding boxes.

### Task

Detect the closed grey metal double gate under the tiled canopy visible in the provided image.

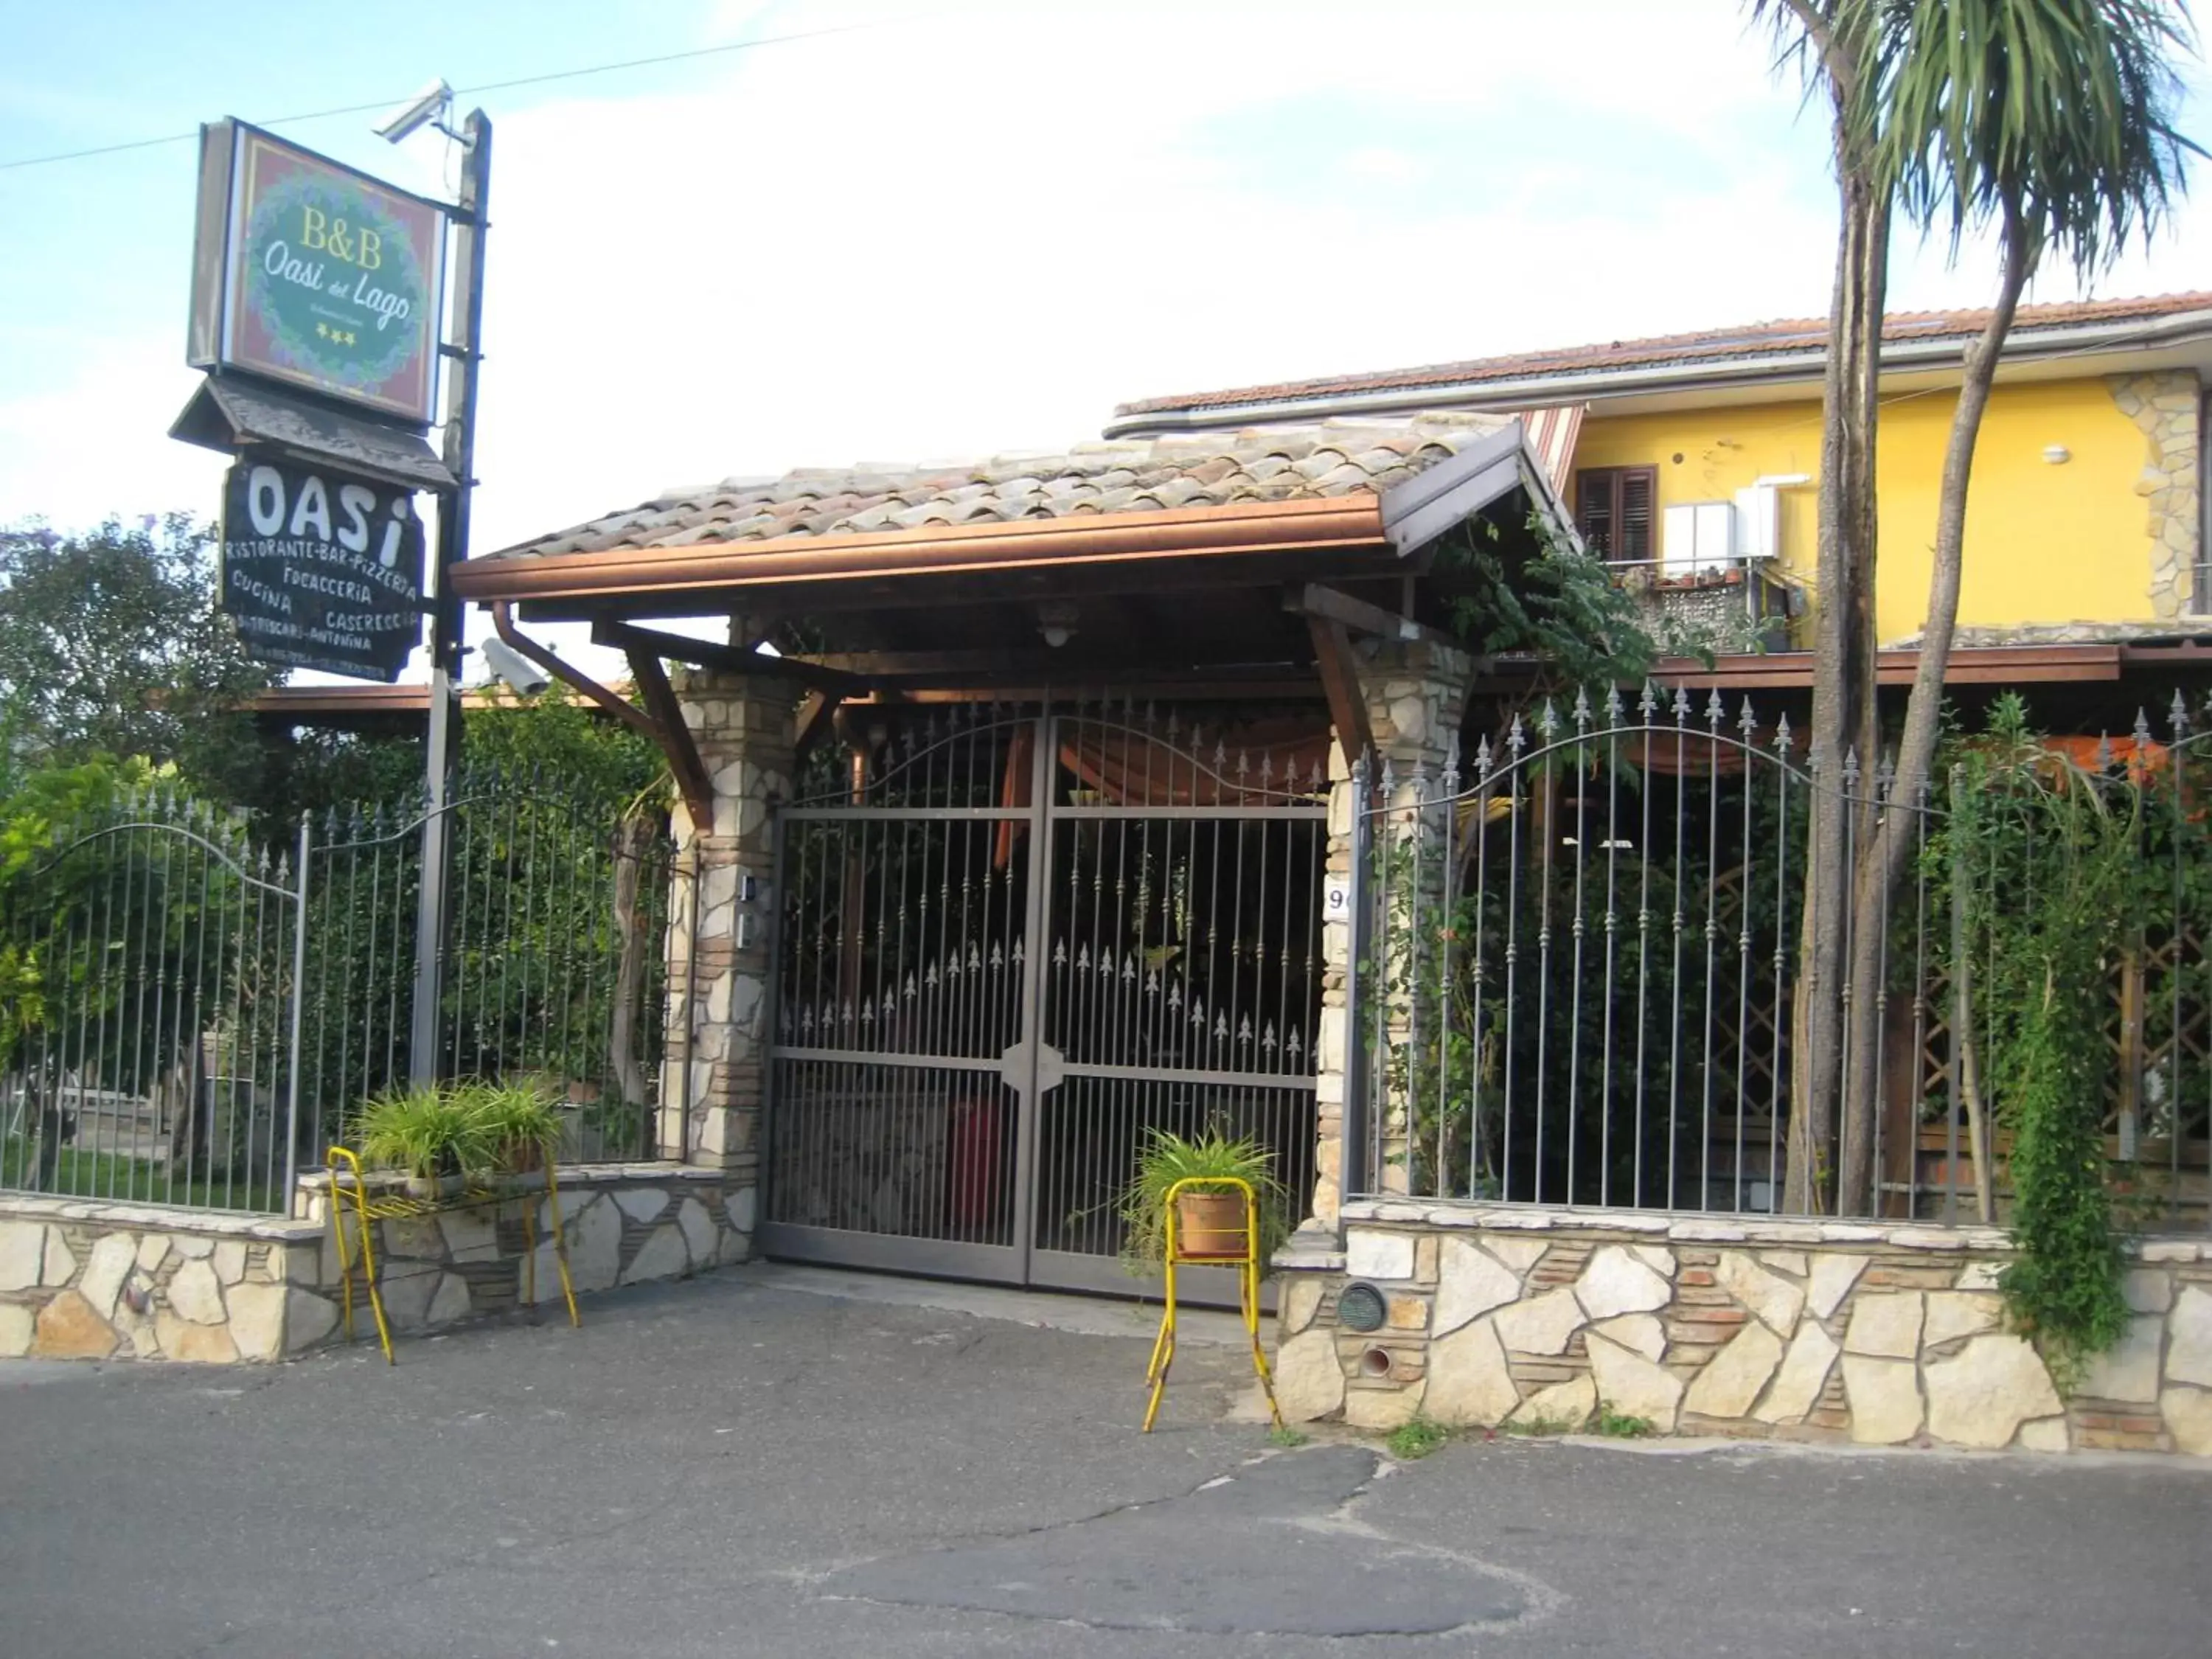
[763,706,1327,1292]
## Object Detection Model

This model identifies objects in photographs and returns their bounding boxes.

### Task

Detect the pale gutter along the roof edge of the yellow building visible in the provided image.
[1104,310,2212,438]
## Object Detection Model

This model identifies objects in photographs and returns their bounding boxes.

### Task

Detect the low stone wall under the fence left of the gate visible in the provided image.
[0,1164,754,1363]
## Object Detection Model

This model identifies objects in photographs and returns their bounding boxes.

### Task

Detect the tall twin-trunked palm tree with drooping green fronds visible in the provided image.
[1752,0,2201,1214]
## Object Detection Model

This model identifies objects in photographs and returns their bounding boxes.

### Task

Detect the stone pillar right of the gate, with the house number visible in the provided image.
[1310,639,1473,1232]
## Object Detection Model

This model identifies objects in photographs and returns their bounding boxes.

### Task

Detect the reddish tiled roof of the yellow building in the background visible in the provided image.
[1115,292,2212,416]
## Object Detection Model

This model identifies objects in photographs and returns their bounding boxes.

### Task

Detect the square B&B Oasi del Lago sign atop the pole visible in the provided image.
[186,122,445,427]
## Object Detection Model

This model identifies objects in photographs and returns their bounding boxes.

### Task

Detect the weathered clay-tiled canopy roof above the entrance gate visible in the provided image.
[491,411,1511,557]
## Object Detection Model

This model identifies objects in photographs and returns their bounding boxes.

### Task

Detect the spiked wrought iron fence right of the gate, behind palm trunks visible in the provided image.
[1349,690,2212,1221]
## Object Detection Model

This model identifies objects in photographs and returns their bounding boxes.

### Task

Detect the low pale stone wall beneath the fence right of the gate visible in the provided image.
[1276,1201,2212,1455]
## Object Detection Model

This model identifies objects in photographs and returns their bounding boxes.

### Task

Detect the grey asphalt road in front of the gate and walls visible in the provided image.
[0,1270,2212,1659]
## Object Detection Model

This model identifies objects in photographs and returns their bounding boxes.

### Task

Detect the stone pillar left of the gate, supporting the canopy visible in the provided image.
[659,670,794,1239]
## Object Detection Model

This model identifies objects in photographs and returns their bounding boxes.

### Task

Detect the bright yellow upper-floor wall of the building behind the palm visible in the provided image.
[1575,378,2154,639]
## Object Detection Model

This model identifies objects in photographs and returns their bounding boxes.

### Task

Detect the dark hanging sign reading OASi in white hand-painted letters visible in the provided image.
[223,460,422,681]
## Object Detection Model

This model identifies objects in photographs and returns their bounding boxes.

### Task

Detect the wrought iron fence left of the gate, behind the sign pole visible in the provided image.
[0,772,681,1212]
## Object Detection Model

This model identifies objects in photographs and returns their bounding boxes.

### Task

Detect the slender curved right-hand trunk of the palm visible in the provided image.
[1836,204,2039,1214]
